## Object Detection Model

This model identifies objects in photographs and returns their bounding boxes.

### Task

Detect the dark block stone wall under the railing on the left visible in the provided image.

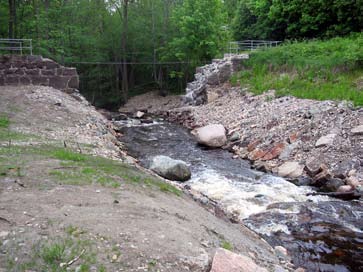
[0,55,79,91]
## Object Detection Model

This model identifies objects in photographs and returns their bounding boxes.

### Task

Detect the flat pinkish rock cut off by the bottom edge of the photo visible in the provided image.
[210,248,267,272]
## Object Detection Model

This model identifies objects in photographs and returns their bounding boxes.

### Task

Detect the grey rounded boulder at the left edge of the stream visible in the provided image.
[150,155,191,181]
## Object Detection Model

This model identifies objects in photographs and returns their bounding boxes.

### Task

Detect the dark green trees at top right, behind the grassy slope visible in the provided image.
[233,0,363,40]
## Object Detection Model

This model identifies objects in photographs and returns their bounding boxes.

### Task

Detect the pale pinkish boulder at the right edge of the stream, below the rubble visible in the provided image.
[194,124,227,147]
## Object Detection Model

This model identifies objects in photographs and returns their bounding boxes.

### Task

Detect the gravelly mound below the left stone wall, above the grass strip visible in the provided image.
[0,86,125,159]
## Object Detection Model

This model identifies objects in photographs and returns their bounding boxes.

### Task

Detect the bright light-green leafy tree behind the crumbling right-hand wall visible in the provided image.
[163,0,228,66]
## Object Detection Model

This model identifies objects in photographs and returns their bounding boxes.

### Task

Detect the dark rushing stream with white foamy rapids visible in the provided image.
[114,119,363,272]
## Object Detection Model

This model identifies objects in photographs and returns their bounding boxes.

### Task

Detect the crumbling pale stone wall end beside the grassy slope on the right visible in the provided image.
[184,54,248,105]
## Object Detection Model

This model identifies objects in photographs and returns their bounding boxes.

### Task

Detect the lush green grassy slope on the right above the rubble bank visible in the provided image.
[231,34,363,106]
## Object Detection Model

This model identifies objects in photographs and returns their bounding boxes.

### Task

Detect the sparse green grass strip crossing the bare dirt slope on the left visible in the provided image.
[0,142,181,196]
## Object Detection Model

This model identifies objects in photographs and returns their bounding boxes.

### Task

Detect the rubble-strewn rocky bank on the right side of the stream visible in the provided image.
[121,83,363,196]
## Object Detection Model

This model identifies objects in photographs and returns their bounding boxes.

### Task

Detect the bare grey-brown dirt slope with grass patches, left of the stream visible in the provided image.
[0,86,278,272]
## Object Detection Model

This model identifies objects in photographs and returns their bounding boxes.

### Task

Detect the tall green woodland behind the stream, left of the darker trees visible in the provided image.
[0,0,227,106]
